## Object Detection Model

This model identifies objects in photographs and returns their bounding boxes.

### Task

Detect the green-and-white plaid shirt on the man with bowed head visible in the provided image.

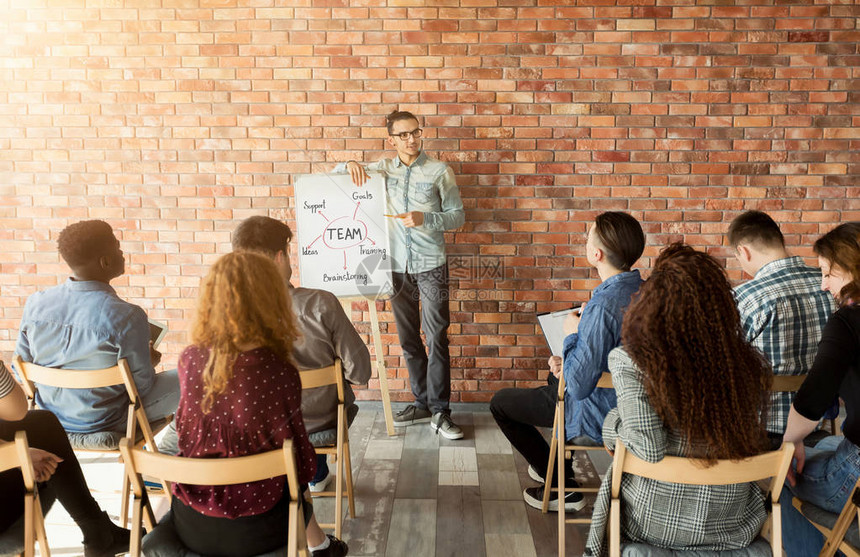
[735,257,836,435]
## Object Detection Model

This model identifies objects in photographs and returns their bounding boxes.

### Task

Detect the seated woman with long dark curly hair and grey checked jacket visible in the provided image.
[586,244,772,556]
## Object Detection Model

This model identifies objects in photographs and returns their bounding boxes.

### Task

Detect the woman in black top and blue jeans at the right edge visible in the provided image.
[781,222,860,556]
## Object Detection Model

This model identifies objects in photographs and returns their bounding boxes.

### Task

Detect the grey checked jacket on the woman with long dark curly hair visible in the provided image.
[585,348,767,556]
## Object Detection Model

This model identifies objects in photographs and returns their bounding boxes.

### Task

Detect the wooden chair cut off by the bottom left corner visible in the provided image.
[0,431,51,557]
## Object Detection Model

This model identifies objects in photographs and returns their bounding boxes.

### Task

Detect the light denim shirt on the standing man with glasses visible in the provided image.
[334,151,466,274]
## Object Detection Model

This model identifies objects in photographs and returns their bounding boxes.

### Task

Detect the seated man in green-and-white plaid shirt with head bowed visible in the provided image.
[729,211,835,448]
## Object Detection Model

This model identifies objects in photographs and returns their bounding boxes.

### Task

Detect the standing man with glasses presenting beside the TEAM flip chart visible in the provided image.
[334,111,465,439]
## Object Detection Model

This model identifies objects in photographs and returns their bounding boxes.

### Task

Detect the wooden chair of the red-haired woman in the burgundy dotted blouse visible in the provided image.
[119,439,310,557]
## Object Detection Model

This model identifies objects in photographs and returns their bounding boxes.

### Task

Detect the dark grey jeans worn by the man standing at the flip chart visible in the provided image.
[391,265,451,413]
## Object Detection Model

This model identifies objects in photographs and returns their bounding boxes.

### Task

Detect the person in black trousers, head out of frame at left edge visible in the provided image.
[0,362,129,557]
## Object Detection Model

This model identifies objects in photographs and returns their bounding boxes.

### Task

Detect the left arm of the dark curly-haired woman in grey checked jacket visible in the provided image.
[603,350,666,462]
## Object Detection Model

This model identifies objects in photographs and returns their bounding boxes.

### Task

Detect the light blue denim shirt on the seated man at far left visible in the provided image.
[15,279,155,433]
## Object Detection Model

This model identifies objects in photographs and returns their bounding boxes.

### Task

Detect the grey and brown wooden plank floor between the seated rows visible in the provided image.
[37,405,609,557]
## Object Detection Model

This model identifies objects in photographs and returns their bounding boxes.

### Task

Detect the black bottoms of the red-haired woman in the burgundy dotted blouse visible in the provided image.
[170,484,314,557]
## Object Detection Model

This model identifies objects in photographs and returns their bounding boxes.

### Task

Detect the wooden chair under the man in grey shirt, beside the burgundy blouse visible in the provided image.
[299,358,355,538]
